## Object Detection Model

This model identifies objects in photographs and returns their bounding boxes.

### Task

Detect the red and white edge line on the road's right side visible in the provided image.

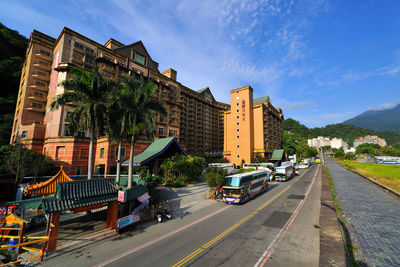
[254,165,319,267]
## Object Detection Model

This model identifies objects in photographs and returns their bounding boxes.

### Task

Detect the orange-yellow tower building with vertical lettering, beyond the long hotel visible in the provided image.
[224,86,283,165]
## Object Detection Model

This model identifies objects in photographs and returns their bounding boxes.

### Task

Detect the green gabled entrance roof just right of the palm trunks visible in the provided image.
[121,137,186,166]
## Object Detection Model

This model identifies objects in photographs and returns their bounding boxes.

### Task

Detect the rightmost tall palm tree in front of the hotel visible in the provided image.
[118,75,166,188]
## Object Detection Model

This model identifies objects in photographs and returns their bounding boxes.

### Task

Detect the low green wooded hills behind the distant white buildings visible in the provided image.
[283,118,400,145]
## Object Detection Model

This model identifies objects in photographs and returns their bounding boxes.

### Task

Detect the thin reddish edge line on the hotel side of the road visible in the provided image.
[94,206,231,267]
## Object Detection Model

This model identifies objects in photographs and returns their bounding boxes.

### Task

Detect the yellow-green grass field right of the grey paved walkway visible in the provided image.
[340,160,400,193]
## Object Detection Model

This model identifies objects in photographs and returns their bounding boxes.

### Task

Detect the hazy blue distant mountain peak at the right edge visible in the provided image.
[343,104,400,134]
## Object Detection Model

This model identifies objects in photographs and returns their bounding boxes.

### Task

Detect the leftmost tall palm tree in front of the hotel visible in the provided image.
[50,67,115,179]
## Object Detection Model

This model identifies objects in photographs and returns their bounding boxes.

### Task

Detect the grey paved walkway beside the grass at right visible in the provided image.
[327,160,400,266]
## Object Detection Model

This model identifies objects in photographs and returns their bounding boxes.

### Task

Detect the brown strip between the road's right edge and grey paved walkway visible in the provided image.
[319,167,348,266]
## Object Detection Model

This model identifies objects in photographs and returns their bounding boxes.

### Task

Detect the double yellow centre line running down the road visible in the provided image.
[173,170,308,267]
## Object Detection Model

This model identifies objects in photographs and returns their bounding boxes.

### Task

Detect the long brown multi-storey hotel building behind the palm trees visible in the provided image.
[10,28,283,174]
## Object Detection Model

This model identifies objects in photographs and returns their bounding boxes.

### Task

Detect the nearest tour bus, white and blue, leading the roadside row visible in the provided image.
[222,170,270,204]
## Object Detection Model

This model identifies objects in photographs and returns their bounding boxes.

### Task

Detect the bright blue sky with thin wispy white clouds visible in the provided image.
[0,0,400,127]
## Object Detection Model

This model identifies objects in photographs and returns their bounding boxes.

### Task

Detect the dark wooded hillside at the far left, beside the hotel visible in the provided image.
[0,23,28,146]
